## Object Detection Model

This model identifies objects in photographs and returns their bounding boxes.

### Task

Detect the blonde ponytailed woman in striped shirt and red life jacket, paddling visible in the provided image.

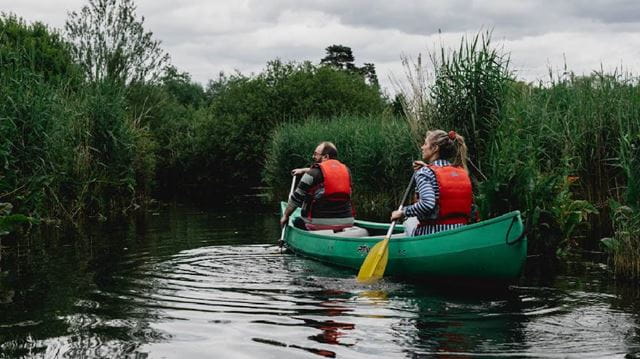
[391,130,473,236]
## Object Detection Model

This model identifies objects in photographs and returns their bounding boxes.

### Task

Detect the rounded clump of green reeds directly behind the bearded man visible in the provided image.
[264,116,417,219]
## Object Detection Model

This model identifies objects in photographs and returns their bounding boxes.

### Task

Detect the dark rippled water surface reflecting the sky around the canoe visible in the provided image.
[0,206,640,358]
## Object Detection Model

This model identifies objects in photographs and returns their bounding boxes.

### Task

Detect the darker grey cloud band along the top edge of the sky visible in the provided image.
[241,0,640,38]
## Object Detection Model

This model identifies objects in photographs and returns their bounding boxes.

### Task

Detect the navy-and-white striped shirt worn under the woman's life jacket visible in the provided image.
[402,159,463,236]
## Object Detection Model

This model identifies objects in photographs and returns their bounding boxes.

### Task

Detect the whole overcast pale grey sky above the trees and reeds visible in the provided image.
[0,0,640,93]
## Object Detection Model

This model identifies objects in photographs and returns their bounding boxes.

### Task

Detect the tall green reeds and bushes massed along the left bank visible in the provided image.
[0,15,153,221]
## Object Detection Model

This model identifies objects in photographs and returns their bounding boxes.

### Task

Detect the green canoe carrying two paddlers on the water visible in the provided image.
[281,202,527,282]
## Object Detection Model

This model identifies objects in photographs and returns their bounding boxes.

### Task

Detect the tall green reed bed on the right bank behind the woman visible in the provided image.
[402,33,640,275]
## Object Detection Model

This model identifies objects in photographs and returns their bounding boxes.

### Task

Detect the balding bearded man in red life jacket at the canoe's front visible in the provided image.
[280,142,353,231]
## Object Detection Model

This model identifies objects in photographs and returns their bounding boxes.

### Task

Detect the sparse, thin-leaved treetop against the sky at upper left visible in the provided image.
[65,0,169,84]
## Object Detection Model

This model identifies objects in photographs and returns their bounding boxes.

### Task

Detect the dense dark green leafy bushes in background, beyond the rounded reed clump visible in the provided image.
[170,61,385,195]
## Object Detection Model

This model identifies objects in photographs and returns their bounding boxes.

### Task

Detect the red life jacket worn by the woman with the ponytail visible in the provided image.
[420,166,473,225]
